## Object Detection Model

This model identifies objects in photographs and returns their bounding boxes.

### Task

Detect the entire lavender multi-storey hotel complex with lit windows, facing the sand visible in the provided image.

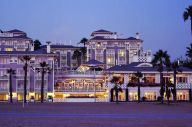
[0,30,192,102]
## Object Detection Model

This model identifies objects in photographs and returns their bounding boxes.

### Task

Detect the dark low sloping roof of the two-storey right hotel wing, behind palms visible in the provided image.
[107,62,192,72]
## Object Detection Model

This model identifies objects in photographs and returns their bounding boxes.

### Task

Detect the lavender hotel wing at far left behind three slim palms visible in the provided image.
[0,30,55,101]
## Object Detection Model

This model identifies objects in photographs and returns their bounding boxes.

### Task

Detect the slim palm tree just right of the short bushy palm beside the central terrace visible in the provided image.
[134,71,143,103]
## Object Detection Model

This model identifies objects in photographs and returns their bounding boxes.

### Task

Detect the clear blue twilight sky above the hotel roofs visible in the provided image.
[0,0,192,59]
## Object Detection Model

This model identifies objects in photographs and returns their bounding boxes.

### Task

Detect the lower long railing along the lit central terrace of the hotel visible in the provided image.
[55,88,106,92]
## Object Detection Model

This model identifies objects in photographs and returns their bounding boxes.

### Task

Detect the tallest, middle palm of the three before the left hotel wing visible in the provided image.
[21,55,31,103]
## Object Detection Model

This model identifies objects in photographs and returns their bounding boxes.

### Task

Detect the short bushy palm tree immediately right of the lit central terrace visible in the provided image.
[110,76,122,104]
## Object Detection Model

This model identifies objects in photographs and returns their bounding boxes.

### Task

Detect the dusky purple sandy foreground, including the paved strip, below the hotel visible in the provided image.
[0,102,192,127]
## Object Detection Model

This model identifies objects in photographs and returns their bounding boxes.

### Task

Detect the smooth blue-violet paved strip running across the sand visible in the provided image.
[0,112,192,120]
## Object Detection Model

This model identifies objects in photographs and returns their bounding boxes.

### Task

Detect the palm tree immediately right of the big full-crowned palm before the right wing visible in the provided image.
[171,61,182,101]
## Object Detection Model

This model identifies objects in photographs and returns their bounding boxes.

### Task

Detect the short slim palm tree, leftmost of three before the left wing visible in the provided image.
[7,68,15,103]
